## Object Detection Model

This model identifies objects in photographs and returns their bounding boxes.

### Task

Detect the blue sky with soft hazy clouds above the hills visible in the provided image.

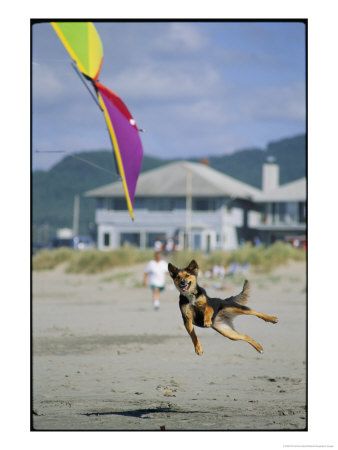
[31,21,306,169]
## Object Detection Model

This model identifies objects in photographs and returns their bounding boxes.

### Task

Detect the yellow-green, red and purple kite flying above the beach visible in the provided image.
[51,22,143,220]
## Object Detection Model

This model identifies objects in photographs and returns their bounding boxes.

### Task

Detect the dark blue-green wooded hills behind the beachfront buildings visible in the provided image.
[32,135,306,242]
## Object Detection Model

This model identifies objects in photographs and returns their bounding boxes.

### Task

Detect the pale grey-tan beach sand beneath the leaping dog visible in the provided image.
[32,262,307,431]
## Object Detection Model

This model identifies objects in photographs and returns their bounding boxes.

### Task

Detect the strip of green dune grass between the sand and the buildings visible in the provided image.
[32,241,306,274]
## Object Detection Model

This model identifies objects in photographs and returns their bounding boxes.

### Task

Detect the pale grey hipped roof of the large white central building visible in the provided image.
[85,161,262,200]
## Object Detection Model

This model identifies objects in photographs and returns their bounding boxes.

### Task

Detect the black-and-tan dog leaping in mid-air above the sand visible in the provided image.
[168,260,278,355]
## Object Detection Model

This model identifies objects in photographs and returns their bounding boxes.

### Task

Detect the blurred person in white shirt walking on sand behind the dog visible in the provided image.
[143,251,168,311]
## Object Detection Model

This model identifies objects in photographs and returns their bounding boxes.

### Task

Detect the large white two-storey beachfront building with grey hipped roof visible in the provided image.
[86,161,305,251]
